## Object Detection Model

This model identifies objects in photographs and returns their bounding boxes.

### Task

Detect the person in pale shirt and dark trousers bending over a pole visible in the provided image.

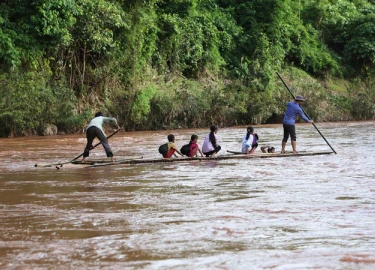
[82,112,120,162]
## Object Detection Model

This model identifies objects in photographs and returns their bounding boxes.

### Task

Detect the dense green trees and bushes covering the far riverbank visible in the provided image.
[0,0,375,136]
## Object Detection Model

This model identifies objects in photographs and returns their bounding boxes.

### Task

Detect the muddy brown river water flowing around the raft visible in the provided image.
[0,122,375,269]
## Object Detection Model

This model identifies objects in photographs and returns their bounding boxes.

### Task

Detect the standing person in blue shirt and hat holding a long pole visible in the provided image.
[281,96,314,153]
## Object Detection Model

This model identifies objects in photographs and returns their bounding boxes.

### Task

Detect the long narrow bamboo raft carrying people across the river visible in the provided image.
[35,150,333,169]
